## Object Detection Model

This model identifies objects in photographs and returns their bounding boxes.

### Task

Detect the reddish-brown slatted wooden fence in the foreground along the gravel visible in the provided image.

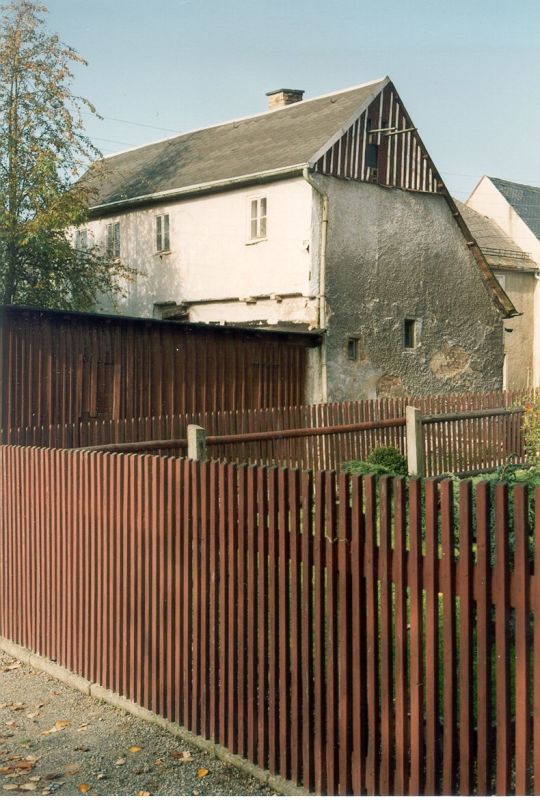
[0,447,540,795]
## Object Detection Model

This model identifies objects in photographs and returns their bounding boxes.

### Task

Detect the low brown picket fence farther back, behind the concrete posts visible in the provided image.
[3,391,523,475]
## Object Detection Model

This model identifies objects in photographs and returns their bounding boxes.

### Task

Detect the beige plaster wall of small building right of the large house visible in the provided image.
[495,269,538,389]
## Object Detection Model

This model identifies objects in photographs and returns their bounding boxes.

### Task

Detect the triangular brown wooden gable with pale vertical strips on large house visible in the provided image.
[314,81,444,193]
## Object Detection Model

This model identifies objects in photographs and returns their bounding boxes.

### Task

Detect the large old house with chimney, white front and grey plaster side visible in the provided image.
[79,78,516,400]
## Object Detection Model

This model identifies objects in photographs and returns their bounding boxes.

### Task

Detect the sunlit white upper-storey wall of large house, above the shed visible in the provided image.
[88,178,318,327]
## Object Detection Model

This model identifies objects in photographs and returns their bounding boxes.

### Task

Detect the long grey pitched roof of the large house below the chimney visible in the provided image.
[83,78,388,207]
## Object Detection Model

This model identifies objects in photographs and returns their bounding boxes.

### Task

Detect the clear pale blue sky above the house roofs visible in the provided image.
[47,0,540,199]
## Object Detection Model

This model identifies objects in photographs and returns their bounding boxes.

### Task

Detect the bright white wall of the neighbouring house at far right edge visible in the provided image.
[467,176,540,386]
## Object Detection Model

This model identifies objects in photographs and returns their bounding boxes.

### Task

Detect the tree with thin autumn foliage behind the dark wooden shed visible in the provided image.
[0,0,131,310]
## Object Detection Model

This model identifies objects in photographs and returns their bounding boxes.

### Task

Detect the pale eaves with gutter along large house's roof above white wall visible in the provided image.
[89,163,308,216]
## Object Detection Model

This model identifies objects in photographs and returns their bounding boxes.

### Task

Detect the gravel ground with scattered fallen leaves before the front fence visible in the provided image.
[0,651,276,796]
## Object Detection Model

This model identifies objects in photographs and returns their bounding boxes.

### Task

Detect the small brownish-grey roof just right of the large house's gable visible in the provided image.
[455,200,536,270]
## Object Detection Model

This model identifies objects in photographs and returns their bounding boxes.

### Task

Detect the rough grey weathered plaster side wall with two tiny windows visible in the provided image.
[317,178,503,400]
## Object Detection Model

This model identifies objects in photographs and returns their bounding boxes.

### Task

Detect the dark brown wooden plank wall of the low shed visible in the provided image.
[0,309,306,429]
